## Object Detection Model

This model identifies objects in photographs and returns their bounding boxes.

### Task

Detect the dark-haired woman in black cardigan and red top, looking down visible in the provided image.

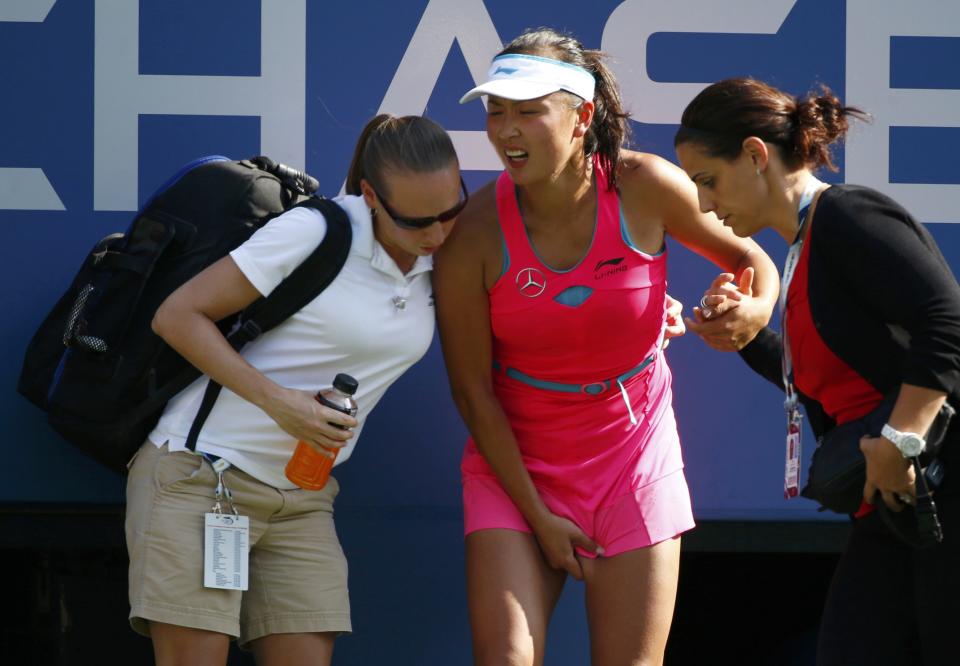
[675,79,960,666]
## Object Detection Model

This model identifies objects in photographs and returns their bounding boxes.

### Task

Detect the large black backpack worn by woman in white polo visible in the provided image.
[17,156,351,471]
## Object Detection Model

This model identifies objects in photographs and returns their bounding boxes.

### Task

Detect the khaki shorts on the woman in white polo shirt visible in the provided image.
[126,442,351,645]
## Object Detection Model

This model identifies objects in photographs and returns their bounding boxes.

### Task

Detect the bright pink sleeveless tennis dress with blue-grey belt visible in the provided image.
[461,165,694,557]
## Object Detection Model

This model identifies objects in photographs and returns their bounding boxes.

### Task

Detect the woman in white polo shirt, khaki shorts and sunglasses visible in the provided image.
[126,115,467,665]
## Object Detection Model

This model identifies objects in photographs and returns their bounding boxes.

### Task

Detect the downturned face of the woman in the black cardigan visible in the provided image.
[677,142,766,238]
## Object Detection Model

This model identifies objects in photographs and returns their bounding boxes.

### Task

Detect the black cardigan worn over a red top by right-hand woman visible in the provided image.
[740,185,960,437]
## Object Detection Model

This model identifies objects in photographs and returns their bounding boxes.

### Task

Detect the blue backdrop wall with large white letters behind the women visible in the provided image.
[0,0,960,664]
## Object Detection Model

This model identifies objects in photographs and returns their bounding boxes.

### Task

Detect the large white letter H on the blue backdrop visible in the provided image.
[93,0,306,210]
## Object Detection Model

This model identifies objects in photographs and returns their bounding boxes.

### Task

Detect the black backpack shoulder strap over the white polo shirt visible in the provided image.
[186,197,353,451]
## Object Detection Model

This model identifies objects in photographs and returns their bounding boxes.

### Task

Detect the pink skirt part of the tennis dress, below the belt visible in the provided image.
[460,354,694,557]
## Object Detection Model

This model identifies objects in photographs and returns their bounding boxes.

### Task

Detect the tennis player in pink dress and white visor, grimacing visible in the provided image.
[434,29,777,666]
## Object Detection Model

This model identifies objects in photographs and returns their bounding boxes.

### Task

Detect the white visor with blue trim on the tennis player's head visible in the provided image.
[460,53,596,104]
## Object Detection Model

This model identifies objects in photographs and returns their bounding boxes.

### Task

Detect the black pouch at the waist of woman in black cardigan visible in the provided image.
[800,392,955,514]
